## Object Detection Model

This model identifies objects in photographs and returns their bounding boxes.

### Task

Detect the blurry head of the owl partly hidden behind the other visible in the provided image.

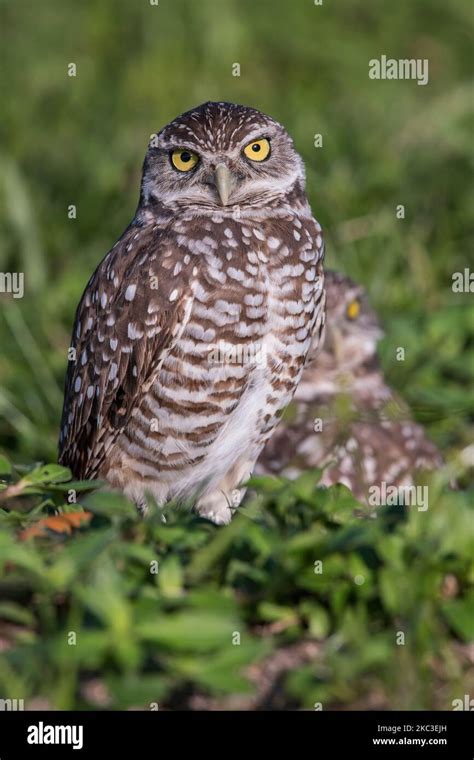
[304,270,383,379]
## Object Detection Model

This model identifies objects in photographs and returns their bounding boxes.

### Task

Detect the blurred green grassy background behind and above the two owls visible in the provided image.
[0,0,474,459]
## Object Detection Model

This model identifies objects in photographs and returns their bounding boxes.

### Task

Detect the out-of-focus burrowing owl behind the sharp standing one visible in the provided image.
[256,271,441,501]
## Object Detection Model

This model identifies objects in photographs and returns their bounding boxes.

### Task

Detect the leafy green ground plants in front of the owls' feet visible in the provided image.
[0,462,474,709]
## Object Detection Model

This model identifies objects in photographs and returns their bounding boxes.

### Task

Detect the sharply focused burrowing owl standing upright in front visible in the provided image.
[59,103,324,523]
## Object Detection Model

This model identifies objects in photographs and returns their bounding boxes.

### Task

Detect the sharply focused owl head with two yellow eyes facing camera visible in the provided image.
[140,102,304,211]
